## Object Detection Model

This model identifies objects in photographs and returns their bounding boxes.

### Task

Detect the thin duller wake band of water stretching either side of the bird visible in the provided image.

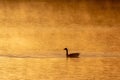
[0,53,120,58]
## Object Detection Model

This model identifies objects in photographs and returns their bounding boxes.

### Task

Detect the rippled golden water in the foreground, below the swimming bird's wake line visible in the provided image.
[0,57,120,80]
